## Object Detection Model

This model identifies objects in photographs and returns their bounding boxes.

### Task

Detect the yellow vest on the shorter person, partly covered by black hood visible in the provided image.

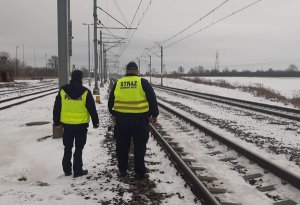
[60,89,90,125]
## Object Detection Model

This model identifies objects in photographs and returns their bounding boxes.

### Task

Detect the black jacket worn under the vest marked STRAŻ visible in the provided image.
[108,74,159,117]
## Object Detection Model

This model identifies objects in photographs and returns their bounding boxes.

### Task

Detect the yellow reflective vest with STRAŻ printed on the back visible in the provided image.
[112,76,149,113]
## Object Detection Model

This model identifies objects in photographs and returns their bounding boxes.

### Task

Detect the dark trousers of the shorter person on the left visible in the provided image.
[62,126,87,173]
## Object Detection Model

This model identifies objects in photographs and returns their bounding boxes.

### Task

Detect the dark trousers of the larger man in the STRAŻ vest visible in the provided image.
[115,115,149,174]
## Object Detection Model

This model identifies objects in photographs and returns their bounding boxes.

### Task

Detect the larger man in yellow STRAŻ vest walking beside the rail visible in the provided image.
[108,62,159,179]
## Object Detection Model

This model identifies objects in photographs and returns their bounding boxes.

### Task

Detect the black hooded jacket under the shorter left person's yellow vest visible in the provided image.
[53,81,99,127]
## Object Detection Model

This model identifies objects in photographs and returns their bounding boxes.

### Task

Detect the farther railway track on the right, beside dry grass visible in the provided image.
[153,85,300,121]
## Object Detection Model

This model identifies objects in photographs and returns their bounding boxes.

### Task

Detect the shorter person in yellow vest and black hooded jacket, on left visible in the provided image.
[53,70,99,178]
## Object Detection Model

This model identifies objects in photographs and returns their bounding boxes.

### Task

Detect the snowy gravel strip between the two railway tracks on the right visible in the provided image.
[156,90,300,175]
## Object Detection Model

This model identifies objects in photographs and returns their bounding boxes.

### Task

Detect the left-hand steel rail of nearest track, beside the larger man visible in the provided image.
[150,124,220,205]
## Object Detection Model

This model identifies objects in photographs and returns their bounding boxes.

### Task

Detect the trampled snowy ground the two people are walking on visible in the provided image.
[0,83,199,205]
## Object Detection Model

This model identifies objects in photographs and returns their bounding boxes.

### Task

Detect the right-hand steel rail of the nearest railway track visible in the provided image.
[158,102,300,189]
